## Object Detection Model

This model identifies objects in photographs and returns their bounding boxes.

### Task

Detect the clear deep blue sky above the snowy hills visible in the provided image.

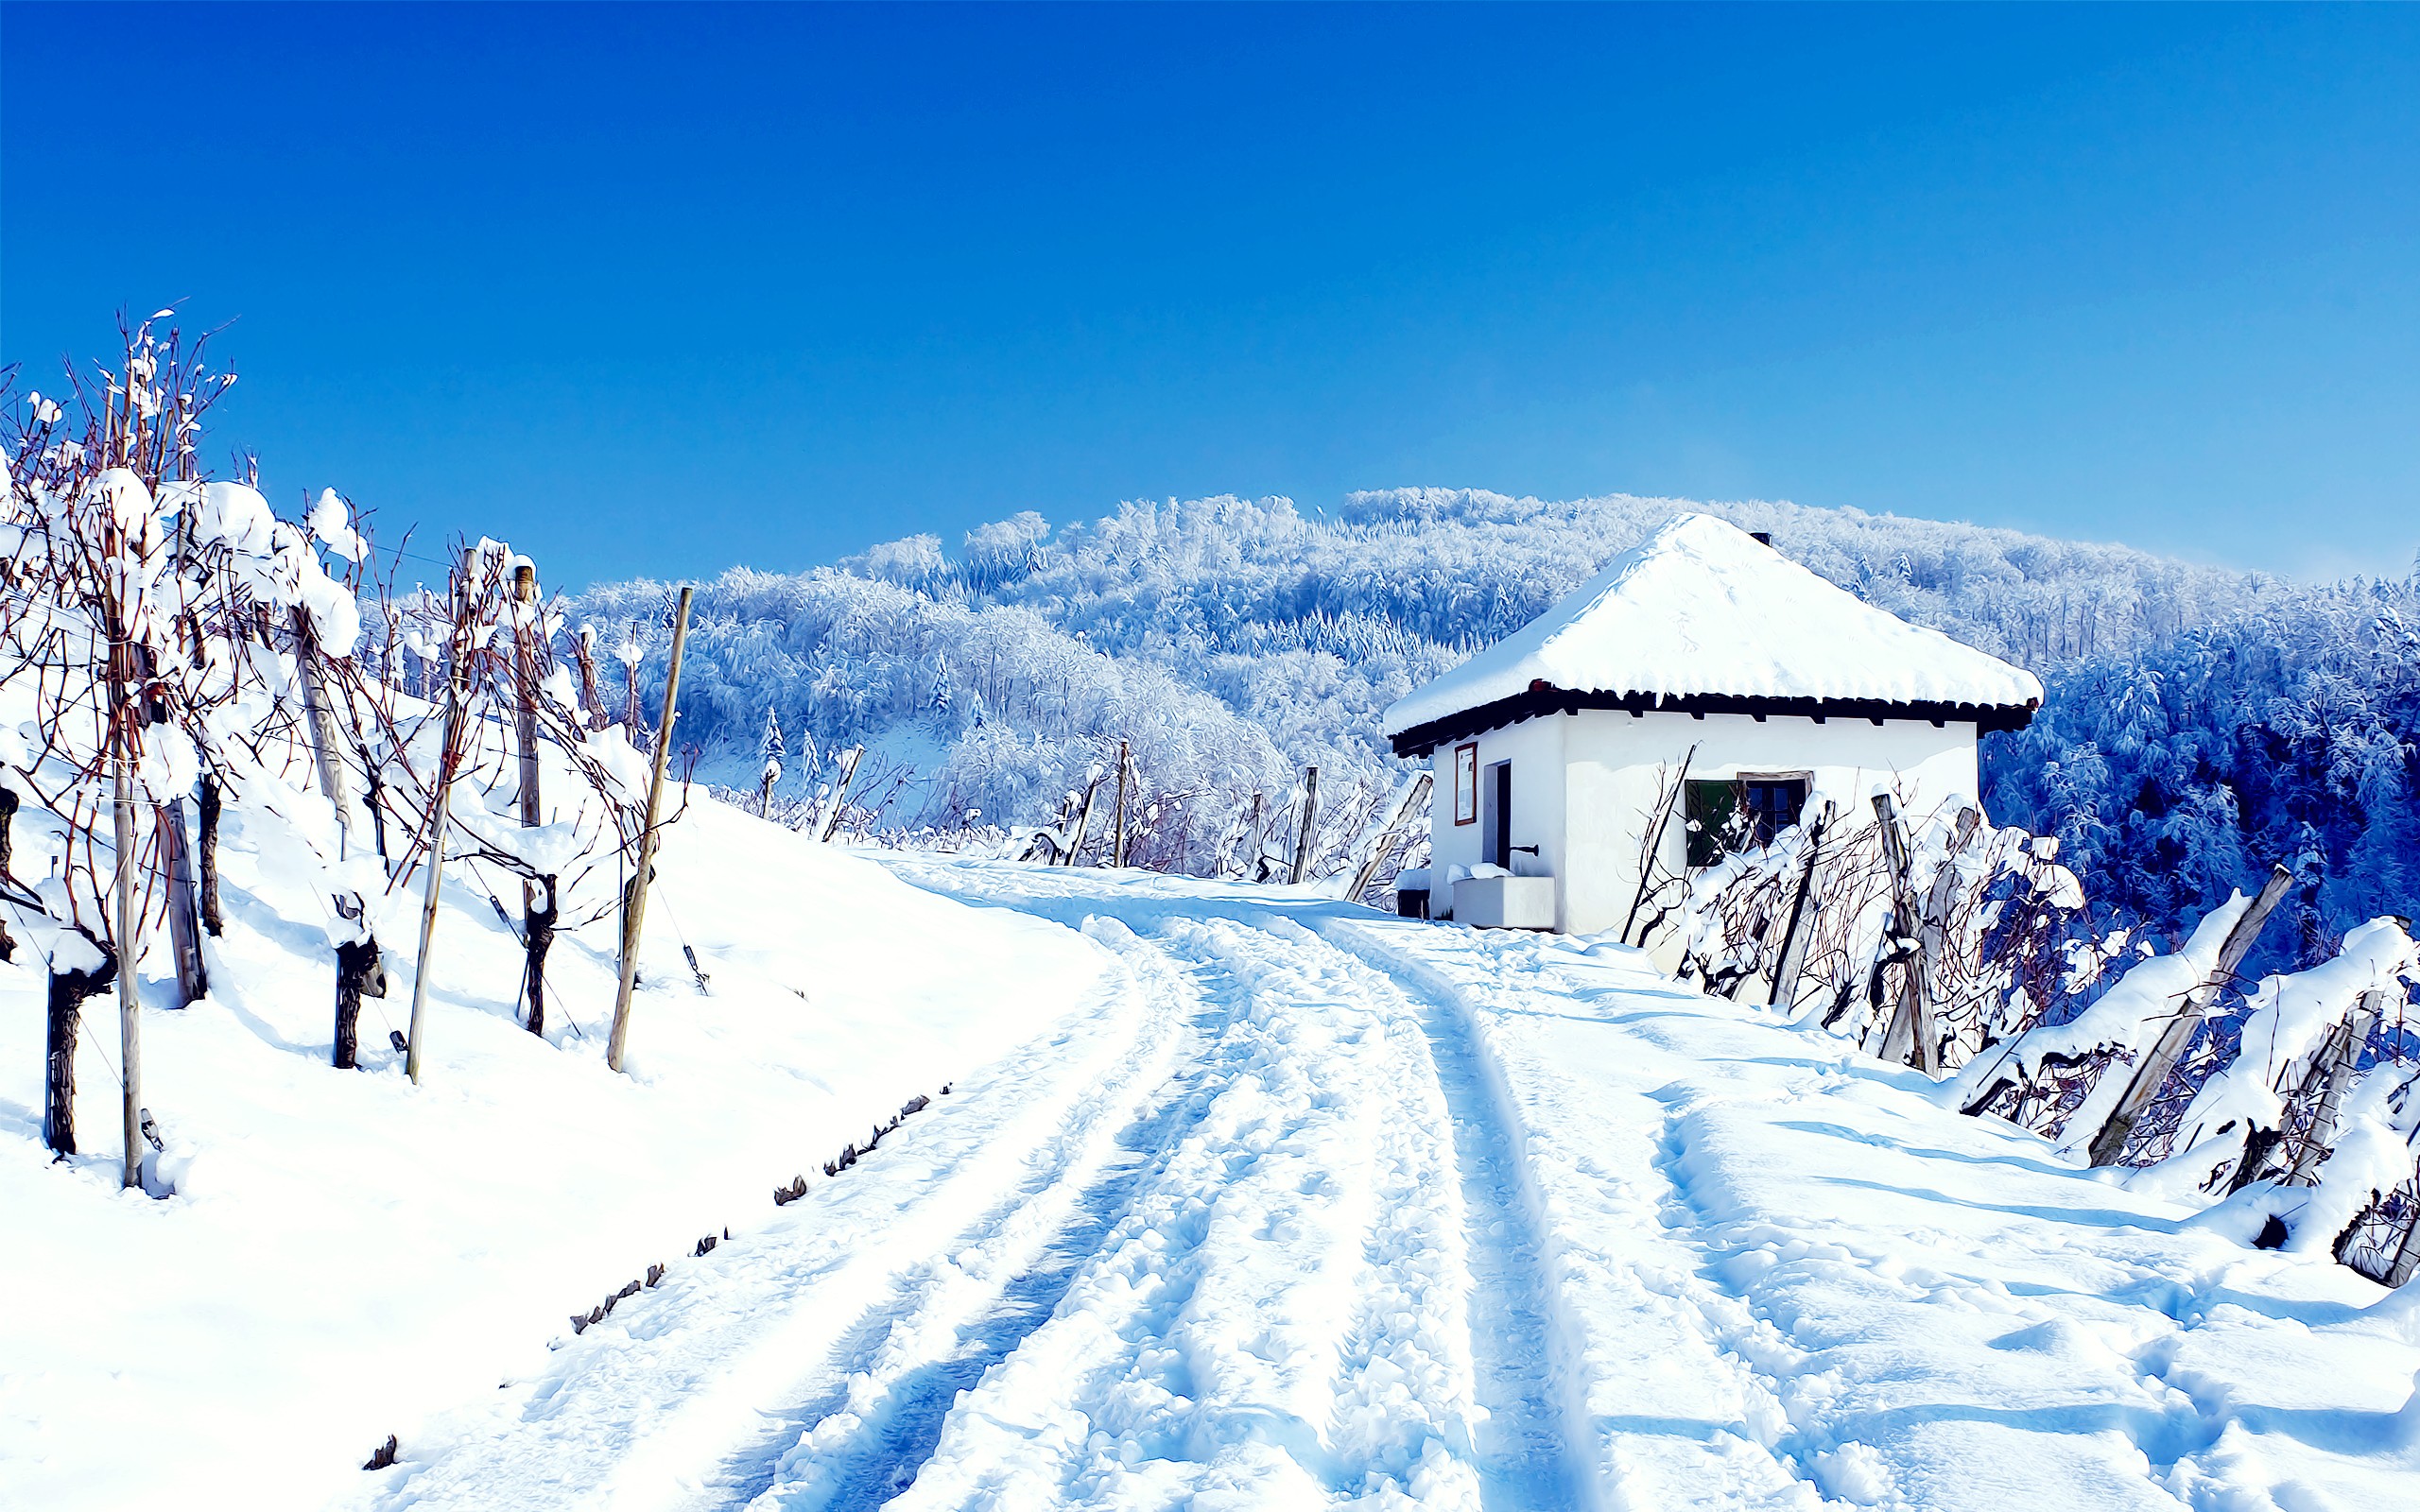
[0,5,2420,586]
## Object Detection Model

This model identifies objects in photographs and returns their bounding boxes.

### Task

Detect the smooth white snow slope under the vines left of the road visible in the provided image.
[0,803,1108,1509]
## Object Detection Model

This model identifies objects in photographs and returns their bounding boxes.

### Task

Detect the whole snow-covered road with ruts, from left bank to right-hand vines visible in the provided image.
[349,861,2420,1512]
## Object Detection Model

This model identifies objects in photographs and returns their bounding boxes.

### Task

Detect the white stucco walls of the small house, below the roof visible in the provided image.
[1430,709,1978,934]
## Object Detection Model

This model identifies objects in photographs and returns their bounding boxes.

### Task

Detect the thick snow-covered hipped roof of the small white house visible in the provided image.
[1387,515,2043,735]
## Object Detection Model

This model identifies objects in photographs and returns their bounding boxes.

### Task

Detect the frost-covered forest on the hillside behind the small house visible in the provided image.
[571,489,2420,954]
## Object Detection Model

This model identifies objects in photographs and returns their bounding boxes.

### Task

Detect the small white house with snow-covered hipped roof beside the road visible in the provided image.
[1387,515,2043,934]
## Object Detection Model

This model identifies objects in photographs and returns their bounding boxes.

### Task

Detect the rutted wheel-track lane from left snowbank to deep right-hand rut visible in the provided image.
[351,868,1578,1509]
